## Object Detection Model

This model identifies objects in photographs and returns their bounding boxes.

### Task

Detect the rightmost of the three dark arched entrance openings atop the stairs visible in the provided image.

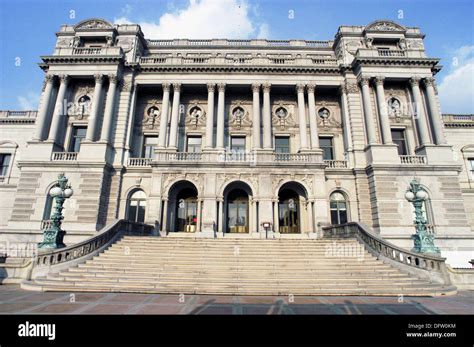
[278,182,307,234]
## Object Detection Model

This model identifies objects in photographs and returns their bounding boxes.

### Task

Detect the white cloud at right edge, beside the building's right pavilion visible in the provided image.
[438,46,474,114]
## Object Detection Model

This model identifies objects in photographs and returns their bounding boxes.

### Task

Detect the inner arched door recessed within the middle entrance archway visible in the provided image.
[227,189,249,233]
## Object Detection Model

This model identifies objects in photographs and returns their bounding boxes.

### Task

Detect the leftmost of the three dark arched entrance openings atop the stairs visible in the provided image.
[168,181,200,232]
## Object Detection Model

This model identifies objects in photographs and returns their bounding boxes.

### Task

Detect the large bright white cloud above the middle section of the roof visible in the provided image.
[114,0,269,39]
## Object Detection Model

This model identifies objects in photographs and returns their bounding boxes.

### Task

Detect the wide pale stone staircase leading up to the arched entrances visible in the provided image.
[22,235,453,296]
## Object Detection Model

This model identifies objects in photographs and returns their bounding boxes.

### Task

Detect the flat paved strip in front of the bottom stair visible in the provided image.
[0,285,474,315]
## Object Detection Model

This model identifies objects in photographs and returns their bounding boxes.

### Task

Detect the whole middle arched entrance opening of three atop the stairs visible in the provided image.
[224,182,252,233]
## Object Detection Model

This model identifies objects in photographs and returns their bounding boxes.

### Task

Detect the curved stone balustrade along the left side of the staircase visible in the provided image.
[31,219,154,278]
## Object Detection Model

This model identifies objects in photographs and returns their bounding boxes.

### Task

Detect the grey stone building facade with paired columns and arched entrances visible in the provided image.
[0,19,474,266]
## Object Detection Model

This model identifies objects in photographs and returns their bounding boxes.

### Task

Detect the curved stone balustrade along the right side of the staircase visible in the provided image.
[322,222,451,285]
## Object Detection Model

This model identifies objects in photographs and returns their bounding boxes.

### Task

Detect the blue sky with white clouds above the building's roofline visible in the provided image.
[0,0,474,113]
